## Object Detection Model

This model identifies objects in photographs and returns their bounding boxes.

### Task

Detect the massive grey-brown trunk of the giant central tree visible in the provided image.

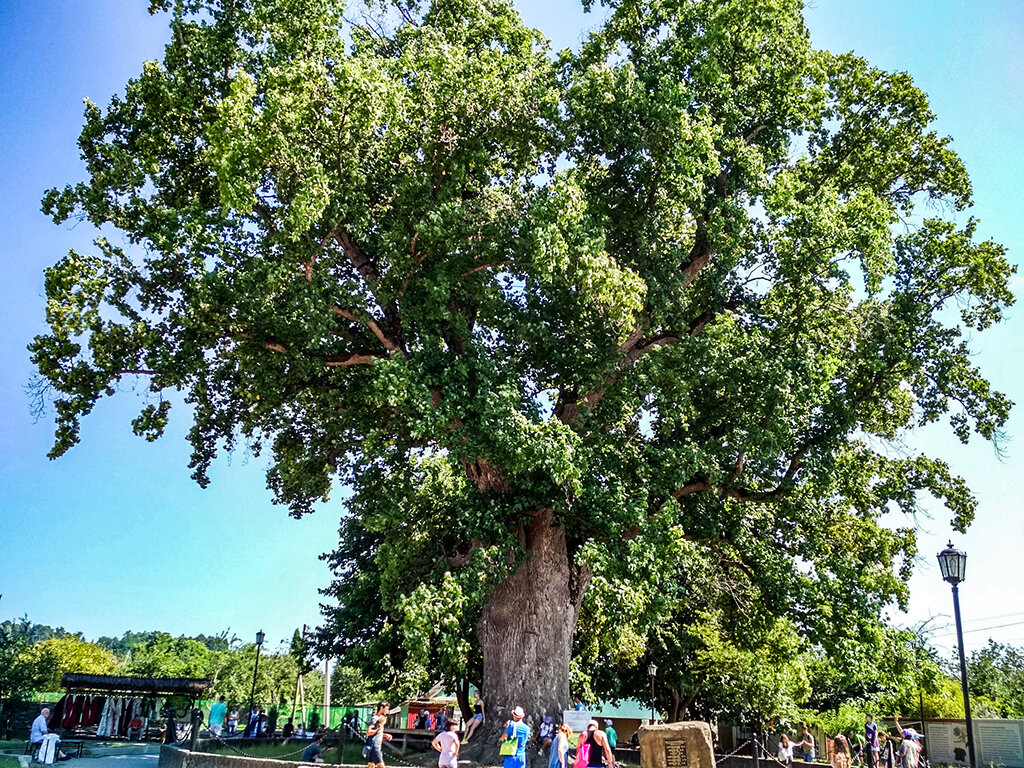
[474,509,590,729]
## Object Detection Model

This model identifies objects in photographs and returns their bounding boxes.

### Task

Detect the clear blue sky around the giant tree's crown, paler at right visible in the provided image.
[0,0,1024,649]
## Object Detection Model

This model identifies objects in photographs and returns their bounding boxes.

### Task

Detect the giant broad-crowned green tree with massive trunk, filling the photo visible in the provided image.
[31,0,1012,733]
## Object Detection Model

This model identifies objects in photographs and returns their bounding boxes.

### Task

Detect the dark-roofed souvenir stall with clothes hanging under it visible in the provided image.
[54,673,210,740]
